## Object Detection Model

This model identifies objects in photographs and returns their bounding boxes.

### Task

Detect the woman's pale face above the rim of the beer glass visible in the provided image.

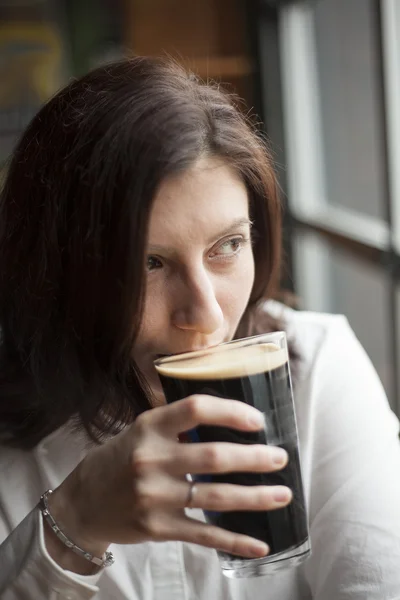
[134,158,254,400]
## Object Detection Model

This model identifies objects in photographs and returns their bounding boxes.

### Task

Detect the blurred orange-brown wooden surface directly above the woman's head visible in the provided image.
[124,0,253,104]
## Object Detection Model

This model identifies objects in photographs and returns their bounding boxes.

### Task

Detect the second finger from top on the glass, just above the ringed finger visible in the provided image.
[167,442,288,475]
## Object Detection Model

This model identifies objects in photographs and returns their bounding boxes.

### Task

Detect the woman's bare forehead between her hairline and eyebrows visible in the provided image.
[149,158,248,243]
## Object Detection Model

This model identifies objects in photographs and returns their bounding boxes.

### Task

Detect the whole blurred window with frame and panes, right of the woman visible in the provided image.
[258,0,400,416]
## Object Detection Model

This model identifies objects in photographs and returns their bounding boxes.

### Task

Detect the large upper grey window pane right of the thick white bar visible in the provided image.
[314,0,386,219]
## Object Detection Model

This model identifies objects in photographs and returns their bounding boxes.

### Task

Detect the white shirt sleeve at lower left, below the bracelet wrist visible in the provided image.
[0,508,102,600]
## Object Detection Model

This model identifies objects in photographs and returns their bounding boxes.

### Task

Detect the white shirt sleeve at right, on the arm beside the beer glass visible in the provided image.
[302,317,400,600]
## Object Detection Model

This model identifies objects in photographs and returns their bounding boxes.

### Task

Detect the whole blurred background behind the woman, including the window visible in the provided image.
[0,0,400,415]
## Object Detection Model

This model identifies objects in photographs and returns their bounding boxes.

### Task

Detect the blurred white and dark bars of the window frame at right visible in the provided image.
[253,0,400,416]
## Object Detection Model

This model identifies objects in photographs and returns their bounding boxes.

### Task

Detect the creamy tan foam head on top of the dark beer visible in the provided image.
[155,343,287,379]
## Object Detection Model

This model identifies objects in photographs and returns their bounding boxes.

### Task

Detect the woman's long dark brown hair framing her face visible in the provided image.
[0,58,281,448]
